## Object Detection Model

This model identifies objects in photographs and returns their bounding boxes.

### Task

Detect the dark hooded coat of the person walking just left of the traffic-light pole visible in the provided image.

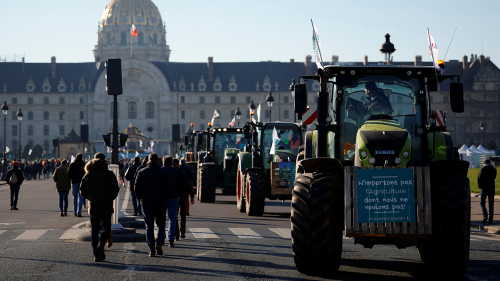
[80,159,120,216]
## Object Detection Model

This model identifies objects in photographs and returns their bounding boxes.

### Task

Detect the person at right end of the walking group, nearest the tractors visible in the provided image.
[172,159,194,240]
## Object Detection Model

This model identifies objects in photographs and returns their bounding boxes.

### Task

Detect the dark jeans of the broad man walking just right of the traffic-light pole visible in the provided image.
[142,203,166,249]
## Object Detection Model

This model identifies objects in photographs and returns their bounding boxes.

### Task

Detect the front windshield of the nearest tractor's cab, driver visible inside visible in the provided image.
[340,75,425,164]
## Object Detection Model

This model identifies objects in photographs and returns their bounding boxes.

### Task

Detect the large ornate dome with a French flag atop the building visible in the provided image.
[94,0,170,62]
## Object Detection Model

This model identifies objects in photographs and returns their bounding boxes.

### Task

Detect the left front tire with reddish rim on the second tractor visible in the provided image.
[245,170,266,216]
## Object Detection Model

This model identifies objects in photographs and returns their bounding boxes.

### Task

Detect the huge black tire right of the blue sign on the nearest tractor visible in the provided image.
[418,175,471,278]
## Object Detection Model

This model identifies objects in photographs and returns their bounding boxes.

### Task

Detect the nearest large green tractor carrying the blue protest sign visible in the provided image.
[291,65,470,276]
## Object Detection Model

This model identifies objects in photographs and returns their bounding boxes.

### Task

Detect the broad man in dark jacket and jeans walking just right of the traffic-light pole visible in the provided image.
[134,153,172,257]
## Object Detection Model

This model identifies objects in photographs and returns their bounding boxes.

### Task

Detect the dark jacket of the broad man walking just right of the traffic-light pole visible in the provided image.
[134,163,173,206]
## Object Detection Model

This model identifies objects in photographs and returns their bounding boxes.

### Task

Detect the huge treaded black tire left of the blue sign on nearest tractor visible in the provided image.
[290,173,344,275]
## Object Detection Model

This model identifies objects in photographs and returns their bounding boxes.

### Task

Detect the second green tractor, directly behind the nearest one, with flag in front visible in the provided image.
[236,122,303,216]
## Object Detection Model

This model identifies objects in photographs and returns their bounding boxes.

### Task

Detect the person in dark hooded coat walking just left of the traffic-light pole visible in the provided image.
[80,152,120,261]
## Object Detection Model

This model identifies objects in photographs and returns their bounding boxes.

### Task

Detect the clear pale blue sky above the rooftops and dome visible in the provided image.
[0,0,500,64]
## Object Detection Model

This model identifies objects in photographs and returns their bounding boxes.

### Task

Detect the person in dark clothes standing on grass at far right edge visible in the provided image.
[477,159,497,224]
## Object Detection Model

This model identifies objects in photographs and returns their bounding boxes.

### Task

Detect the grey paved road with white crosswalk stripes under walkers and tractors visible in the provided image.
[0,177,500,280]
